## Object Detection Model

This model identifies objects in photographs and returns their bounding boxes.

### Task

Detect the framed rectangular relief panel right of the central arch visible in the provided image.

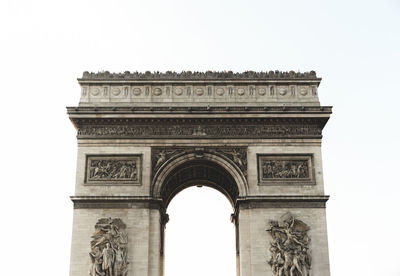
[257,154,315,185]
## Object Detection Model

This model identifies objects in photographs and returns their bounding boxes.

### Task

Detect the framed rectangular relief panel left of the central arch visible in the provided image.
[85,155,142,185]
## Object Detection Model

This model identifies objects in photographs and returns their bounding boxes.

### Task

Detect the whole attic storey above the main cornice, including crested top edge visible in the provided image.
[79,71,321,106]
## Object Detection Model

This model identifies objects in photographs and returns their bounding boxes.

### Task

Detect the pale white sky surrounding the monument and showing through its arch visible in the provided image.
[0,0,400,276]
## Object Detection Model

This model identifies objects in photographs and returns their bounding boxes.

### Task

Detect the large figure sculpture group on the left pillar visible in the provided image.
[89,218,129,276]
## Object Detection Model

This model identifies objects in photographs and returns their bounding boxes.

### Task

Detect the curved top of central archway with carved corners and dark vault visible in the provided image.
[151,147,248,208]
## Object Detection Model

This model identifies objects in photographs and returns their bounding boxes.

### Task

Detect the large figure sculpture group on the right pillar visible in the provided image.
[266,213,311,276]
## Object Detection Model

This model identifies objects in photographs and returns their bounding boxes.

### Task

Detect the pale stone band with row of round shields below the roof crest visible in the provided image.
[80,83,319,106]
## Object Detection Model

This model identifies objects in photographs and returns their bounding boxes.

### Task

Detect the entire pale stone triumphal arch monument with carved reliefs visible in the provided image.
[67,71,332,276]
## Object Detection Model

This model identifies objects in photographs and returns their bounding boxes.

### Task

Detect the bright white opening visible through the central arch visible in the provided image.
[163,187,237,276]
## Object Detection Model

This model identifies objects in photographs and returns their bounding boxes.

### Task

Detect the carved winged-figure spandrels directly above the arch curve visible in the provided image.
[151,147,247,179]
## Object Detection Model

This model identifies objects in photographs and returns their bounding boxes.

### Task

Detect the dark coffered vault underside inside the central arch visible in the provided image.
[161,160,239,208]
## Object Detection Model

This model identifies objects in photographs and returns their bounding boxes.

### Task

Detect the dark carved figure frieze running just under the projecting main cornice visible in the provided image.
[76,119,326,139]
